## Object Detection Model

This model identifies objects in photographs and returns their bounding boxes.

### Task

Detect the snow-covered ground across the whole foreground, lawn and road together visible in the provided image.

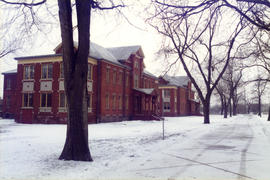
[0,115,270,180]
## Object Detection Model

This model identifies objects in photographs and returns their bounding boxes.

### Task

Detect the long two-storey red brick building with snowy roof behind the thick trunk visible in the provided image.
[3,43,198,123]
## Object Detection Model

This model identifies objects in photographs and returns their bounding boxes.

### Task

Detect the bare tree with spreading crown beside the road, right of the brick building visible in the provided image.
[148,1,245,124]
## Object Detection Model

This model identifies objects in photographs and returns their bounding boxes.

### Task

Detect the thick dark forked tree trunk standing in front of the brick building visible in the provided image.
[58,0,92,161]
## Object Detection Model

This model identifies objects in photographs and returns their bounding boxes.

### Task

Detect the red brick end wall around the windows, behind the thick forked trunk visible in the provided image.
[15,62,97,123]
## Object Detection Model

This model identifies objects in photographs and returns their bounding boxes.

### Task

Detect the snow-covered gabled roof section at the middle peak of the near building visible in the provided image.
[106,45,144,60]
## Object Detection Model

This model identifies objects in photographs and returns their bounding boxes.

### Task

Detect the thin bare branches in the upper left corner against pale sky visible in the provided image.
[0,0,53,58]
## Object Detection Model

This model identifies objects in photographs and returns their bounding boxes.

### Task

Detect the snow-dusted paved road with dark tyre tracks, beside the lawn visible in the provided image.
[133,116,270,180]
